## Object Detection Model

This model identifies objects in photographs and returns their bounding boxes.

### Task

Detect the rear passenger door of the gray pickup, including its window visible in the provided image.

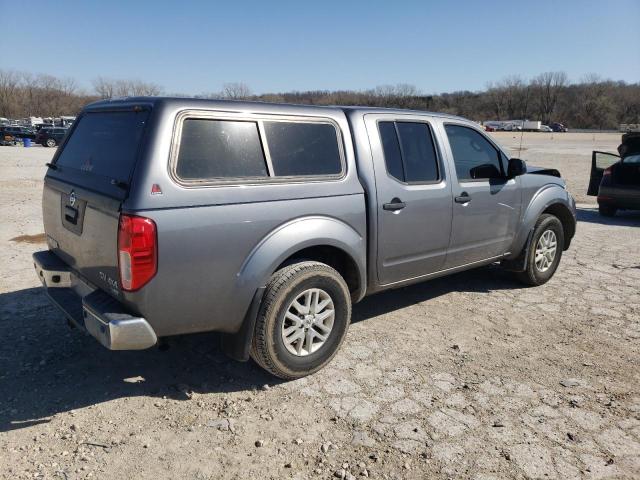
[365,114,452,285]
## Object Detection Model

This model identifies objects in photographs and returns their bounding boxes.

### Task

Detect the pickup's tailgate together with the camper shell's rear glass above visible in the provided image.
[42,108,149,296]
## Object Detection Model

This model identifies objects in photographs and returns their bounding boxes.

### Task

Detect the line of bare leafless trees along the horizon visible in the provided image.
[0,69,640,129]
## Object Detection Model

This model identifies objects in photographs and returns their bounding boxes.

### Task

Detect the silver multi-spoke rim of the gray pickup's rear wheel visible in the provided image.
[281,288,336,357]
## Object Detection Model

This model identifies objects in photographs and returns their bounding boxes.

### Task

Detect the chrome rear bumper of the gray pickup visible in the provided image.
[33,250,158,350]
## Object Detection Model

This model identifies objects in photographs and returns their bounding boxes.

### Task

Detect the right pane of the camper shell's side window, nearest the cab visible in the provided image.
[264,121,342,177]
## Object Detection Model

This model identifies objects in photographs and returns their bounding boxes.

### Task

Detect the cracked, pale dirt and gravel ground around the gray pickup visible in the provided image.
[0,133,640,480]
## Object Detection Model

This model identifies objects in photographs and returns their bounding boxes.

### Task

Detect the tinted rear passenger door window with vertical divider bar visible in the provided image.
[378,122,439,183]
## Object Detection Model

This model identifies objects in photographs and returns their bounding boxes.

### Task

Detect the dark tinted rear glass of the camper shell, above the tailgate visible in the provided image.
[54,110,149,181]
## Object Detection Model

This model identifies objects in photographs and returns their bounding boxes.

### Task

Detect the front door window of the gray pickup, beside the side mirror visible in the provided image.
[445,125,502,181]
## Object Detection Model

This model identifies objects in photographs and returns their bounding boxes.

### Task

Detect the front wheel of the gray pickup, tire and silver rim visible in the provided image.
[516,213,564,286]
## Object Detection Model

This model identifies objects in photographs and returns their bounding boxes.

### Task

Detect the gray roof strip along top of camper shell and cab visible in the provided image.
[87,97,470,122]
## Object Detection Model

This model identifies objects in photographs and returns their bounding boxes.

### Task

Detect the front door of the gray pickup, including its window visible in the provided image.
[444,123,522,268]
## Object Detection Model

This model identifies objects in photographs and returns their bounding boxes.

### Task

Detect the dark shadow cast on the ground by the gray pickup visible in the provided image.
[0,267,518,432]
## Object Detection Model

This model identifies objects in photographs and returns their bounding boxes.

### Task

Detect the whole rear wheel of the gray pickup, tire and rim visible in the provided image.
[251,261,351,380]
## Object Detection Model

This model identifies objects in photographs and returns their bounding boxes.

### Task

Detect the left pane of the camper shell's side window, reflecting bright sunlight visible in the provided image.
[176,119,268,180]
